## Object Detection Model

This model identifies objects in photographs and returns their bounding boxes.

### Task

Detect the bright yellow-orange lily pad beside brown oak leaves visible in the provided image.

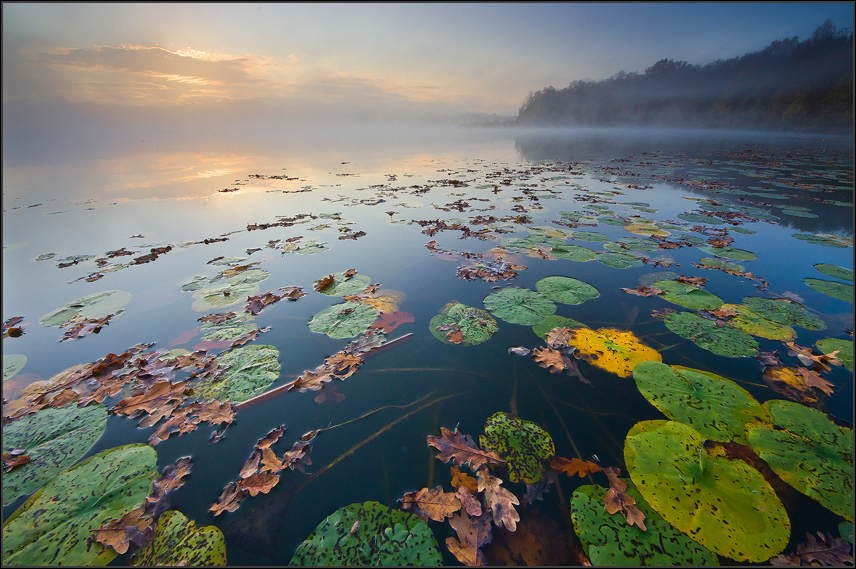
[568,328,663,377]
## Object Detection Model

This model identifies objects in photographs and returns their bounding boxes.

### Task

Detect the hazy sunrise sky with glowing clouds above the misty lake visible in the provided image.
[2,2,853,123]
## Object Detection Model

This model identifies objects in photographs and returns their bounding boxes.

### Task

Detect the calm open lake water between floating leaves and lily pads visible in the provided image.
[3,128,853,565]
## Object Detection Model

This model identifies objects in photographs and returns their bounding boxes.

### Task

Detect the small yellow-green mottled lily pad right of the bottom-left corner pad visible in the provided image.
[131,510,227,567]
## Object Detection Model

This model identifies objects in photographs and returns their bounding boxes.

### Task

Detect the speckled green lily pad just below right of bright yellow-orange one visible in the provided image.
[633,361,768,444]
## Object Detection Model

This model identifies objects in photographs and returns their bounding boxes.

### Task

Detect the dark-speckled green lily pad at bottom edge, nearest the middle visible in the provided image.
[289,502,443,567]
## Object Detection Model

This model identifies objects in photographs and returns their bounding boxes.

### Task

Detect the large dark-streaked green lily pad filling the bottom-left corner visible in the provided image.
[3,444,158,566]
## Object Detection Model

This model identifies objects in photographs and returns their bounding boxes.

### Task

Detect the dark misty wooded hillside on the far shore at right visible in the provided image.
[512,20,853,133]
